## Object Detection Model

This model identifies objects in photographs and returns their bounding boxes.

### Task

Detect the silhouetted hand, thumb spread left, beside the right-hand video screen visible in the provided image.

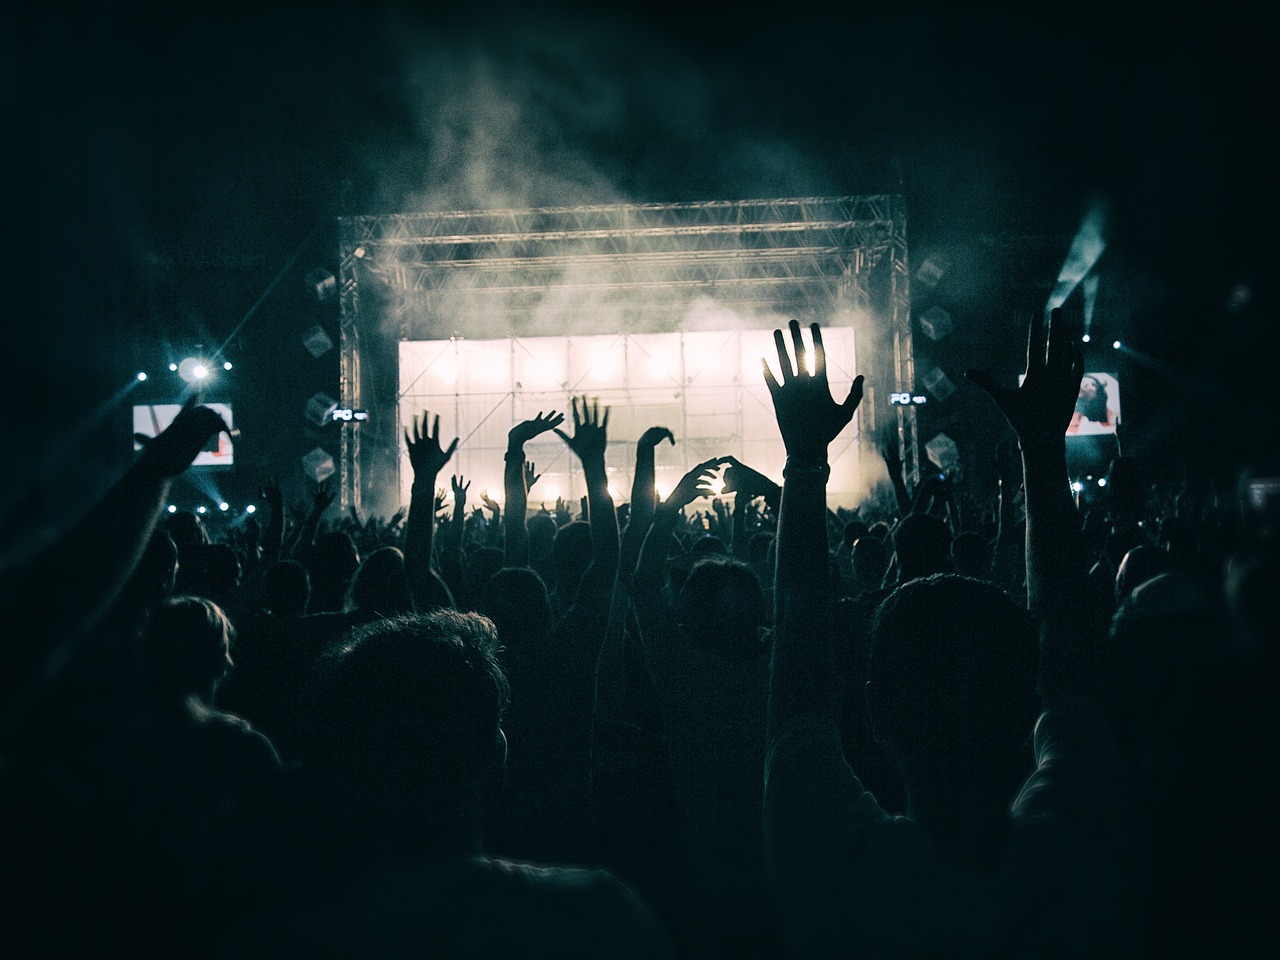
[965,307,1084,443]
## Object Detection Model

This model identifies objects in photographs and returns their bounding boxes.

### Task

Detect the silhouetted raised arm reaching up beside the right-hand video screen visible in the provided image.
[966,310,1089,696]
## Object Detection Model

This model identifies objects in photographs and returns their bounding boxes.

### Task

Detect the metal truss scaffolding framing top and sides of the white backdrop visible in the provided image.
[338,195,919,519]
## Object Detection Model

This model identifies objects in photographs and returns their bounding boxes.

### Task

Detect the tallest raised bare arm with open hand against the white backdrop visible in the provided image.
[763,320,863,745]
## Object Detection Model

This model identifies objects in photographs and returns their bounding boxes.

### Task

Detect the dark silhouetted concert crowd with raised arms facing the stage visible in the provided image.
[0,310,1280,960]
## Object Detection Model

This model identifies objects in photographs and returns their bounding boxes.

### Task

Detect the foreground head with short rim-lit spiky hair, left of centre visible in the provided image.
[302,608,511,792]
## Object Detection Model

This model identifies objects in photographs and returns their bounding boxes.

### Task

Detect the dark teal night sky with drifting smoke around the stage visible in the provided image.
[0,1,1277,542]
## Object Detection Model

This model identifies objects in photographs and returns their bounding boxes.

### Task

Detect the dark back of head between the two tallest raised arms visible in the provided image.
[869,573,1039,762]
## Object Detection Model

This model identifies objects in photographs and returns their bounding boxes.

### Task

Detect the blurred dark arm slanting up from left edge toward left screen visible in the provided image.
[0,397,232,730]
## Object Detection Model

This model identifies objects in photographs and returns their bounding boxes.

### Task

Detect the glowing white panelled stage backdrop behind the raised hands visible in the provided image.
[397,326,865,515]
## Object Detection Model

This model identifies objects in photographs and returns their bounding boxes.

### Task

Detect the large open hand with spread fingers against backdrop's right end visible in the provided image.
[760,320,865,463]
